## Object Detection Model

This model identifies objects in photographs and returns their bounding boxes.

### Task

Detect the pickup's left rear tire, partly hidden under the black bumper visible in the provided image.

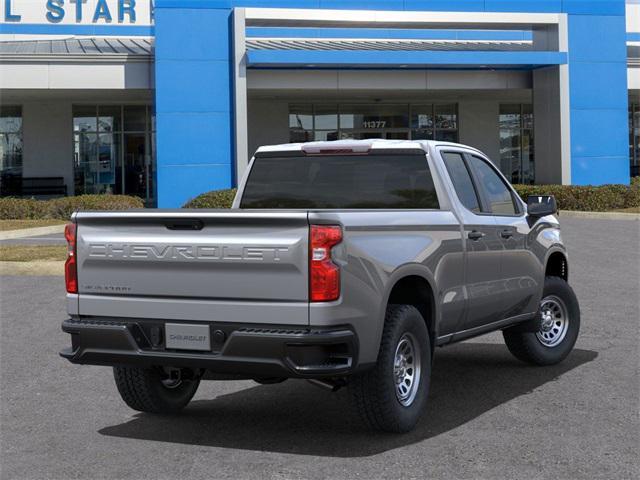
[113,367,200,414]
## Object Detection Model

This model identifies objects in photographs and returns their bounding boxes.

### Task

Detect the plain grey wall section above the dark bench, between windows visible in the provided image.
[22,101,73,195]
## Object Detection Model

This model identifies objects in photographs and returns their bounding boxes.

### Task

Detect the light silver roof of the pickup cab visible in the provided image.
[256,138,477,153]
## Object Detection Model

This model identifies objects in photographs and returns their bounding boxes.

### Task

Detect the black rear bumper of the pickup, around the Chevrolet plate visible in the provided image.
[60,318,358,378]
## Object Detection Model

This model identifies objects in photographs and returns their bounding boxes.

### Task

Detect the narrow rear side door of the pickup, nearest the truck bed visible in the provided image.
[440,147,504,330]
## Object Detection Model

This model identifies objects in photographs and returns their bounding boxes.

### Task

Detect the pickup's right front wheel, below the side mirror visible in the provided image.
[502,277,580,365]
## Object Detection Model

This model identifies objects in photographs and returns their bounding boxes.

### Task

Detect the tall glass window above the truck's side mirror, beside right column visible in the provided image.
[498,104,535,184]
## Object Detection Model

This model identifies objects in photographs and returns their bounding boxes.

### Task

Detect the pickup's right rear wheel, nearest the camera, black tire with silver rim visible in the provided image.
[348,305,431,433]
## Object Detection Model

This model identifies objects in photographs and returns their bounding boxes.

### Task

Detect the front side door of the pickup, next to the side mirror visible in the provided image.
[468,154,541,318]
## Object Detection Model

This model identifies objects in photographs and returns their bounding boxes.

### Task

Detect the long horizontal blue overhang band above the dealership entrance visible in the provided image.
[247,50,567,70]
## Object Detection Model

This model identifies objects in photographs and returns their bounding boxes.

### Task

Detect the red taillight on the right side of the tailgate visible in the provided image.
[309,225,342,302]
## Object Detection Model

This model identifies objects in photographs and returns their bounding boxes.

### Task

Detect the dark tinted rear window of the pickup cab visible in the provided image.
[240,154,439,209]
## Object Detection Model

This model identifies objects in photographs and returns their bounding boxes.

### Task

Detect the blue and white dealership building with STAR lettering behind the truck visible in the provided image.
[0,0,640,207]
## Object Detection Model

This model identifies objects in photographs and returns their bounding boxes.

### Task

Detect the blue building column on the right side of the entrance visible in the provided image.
[569,11,630,185]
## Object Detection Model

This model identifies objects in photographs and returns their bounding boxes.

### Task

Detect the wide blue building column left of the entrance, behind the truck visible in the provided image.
[155,0,236,208]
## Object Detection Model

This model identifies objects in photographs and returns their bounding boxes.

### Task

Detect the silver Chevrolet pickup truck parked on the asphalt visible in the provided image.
[61,140,580,432]
